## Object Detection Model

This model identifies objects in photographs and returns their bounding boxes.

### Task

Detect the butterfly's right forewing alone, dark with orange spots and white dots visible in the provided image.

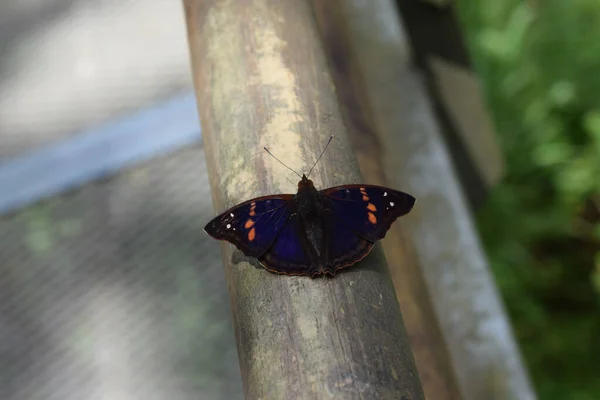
[321,185,415,243]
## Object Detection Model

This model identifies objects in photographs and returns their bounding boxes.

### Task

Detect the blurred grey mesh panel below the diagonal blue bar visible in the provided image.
[0,147,242,400]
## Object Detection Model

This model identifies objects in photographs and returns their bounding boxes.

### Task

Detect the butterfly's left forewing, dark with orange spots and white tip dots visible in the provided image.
[204,194,294,257]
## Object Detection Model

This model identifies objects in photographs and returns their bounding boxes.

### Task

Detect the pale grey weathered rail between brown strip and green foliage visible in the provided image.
[316,0,535,400]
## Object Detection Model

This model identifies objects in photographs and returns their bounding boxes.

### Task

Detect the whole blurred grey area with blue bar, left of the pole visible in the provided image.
[0,0,242,400]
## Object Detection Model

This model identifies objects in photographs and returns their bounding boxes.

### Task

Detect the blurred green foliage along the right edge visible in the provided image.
[459,0,600,400]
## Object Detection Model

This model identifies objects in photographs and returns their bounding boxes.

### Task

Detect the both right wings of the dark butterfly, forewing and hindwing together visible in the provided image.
[321,185,416,269]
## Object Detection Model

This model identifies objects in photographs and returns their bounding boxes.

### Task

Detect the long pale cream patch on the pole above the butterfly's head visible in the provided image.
[249,1,306,188]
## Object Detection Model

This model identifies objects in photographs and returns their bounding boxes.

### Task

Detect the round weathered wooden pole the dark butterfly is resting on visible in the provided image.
[185,0,423,399]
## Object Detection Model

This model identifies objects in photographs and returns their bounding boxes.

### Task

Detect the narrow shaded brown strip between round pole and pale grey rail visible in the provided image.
[313,0,461,400]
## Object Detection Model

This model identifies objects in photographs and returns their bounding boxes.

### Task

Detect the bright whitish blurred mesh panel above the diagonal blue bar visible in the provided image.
[0,0,192,159]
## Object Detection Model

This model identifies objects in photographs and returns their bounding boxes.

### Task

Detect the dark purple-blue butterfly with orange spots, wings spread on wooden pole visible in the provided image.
[204,138,416,278]
